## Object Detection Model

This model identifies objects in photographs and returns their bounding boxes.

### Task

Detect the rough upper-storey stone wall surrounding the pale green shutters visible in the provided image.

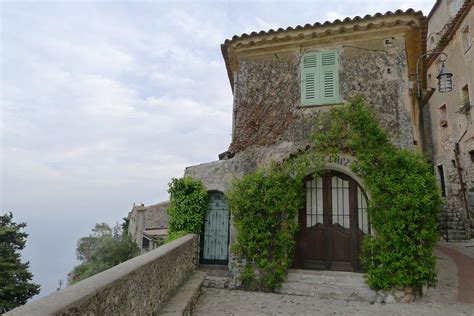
[230,37,416,152]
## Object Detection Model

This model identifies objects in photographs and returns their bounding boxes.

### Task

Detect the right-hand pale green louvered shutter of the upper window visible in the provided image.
[320,51,339,104]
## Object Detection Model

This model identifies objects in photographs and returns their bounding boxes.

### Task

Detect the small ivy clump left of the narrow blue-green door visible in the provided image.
[167,177,208,241]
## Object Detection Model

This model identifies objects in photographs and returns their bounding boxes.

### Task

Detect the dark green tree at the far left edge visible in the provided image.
[0,212,40,313]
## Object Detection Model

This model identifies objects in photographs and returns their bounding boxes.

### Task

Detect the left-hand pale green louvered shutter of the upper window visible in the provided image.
[301,53,321,105]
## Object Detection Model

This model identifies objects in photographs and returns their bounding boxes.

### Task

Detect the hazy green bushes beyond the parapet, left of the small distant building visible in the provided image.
[68,223,140,284]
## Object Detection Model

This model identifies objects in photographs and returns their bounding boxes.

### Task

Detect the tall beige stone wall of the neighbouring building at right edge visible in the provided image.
[423,1,474,241]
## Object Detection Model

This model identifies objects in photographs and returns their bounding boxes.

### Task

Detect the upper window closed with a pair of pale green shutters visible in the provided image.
[301,51,340,105]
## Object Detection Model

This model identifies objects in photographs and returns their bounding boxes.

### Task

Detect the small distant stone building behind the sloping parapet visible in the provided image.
[128,201,169,252]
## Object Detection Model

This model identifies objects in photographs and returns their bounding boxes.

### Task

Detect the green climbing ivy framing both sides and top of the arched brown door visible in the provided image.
[227,98,441,290]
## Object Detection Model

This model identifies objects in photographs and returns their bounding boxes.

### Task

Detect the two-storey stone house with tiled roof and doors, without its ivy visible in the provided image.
[185,9,427,276]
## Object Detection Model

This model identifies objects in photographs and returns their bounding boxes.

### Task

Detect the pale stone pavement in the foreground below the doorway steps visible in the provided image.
[194,250,474,316]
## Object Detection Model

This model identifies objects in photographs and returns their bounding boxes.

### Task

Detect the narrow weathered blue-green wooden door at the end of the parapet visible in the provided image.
[200,191,229,264]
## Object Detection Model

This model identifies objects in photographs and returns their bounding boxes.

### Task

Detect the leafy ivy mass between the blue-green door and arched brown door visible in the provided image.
[227,165,304,291]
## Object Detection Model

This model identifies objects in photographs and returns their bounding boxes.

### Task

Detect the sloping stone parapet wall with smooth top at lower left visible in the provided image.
[6,234,199,315]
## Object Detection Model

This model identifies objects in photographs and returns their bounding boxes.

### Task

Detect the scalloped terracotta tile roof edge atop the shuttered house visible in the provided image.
[221,8,425,89]
